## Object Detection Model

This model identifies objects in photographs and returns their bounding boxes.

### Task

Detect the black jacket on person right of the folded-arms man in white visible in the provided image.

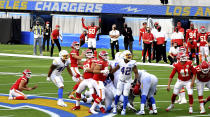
[122,27,134,42]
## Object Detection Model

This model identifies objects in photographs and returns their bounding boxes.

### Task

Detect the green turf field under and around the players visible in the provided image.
[0,45,210,117]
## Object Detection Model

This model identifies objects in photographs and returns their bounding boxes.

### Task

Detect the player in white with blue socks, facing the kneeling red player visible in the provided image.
[47,50,72,107]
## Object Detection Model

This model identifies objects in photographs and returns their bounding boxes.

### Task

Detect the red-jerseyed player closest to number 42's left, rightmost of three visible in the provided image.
[89,51,109,114]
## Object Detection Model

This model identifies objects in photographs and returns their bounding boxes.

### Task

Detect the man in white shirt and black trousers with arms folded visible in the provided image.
[109,24,120,60]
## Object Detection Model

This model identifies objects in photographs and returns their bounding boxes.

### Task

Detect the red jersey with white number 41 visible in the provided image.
[169,60,196,81]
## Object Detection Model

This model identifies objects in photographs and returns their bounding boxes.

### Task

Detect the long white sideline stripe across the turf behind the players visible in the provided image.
[0,53,173,67]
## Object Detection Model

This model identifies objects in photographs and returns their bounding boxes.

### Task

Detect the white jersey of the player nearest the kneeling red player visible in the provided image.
[52,58,71,76]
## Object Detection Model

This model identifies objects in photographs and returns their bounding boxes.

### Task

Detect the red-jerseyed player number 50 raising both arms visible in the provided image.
[82,18,101,55]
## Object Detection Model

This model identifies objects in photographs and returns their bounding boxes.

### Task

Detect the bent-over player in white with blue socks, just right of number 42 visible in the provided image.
[136,70,158,115]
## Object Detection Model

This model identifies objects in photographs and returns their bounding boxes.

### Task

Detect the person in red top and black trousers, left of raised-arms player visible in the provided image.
[50,25,63,57]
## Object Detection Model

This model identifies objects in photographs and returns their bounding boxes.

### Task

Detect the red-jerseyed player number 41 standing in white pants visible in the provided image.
[166,52,196,113]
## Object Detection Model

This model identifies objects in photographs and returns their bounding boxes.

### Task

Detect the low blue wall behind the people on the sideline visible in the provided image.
[21,32,171,52]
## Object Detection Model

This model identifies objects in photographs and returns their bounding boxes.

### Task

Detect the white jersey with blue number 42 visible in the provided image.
[119,59,136,82]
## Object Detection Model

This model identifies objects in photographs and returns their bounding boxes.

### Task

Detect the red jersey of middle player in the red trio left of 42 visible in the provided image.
[83,58,96,79]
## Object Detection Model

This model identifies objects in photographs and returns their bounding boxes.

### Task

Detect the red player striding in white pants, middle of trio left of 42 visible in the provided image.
[72,49,96,110]
